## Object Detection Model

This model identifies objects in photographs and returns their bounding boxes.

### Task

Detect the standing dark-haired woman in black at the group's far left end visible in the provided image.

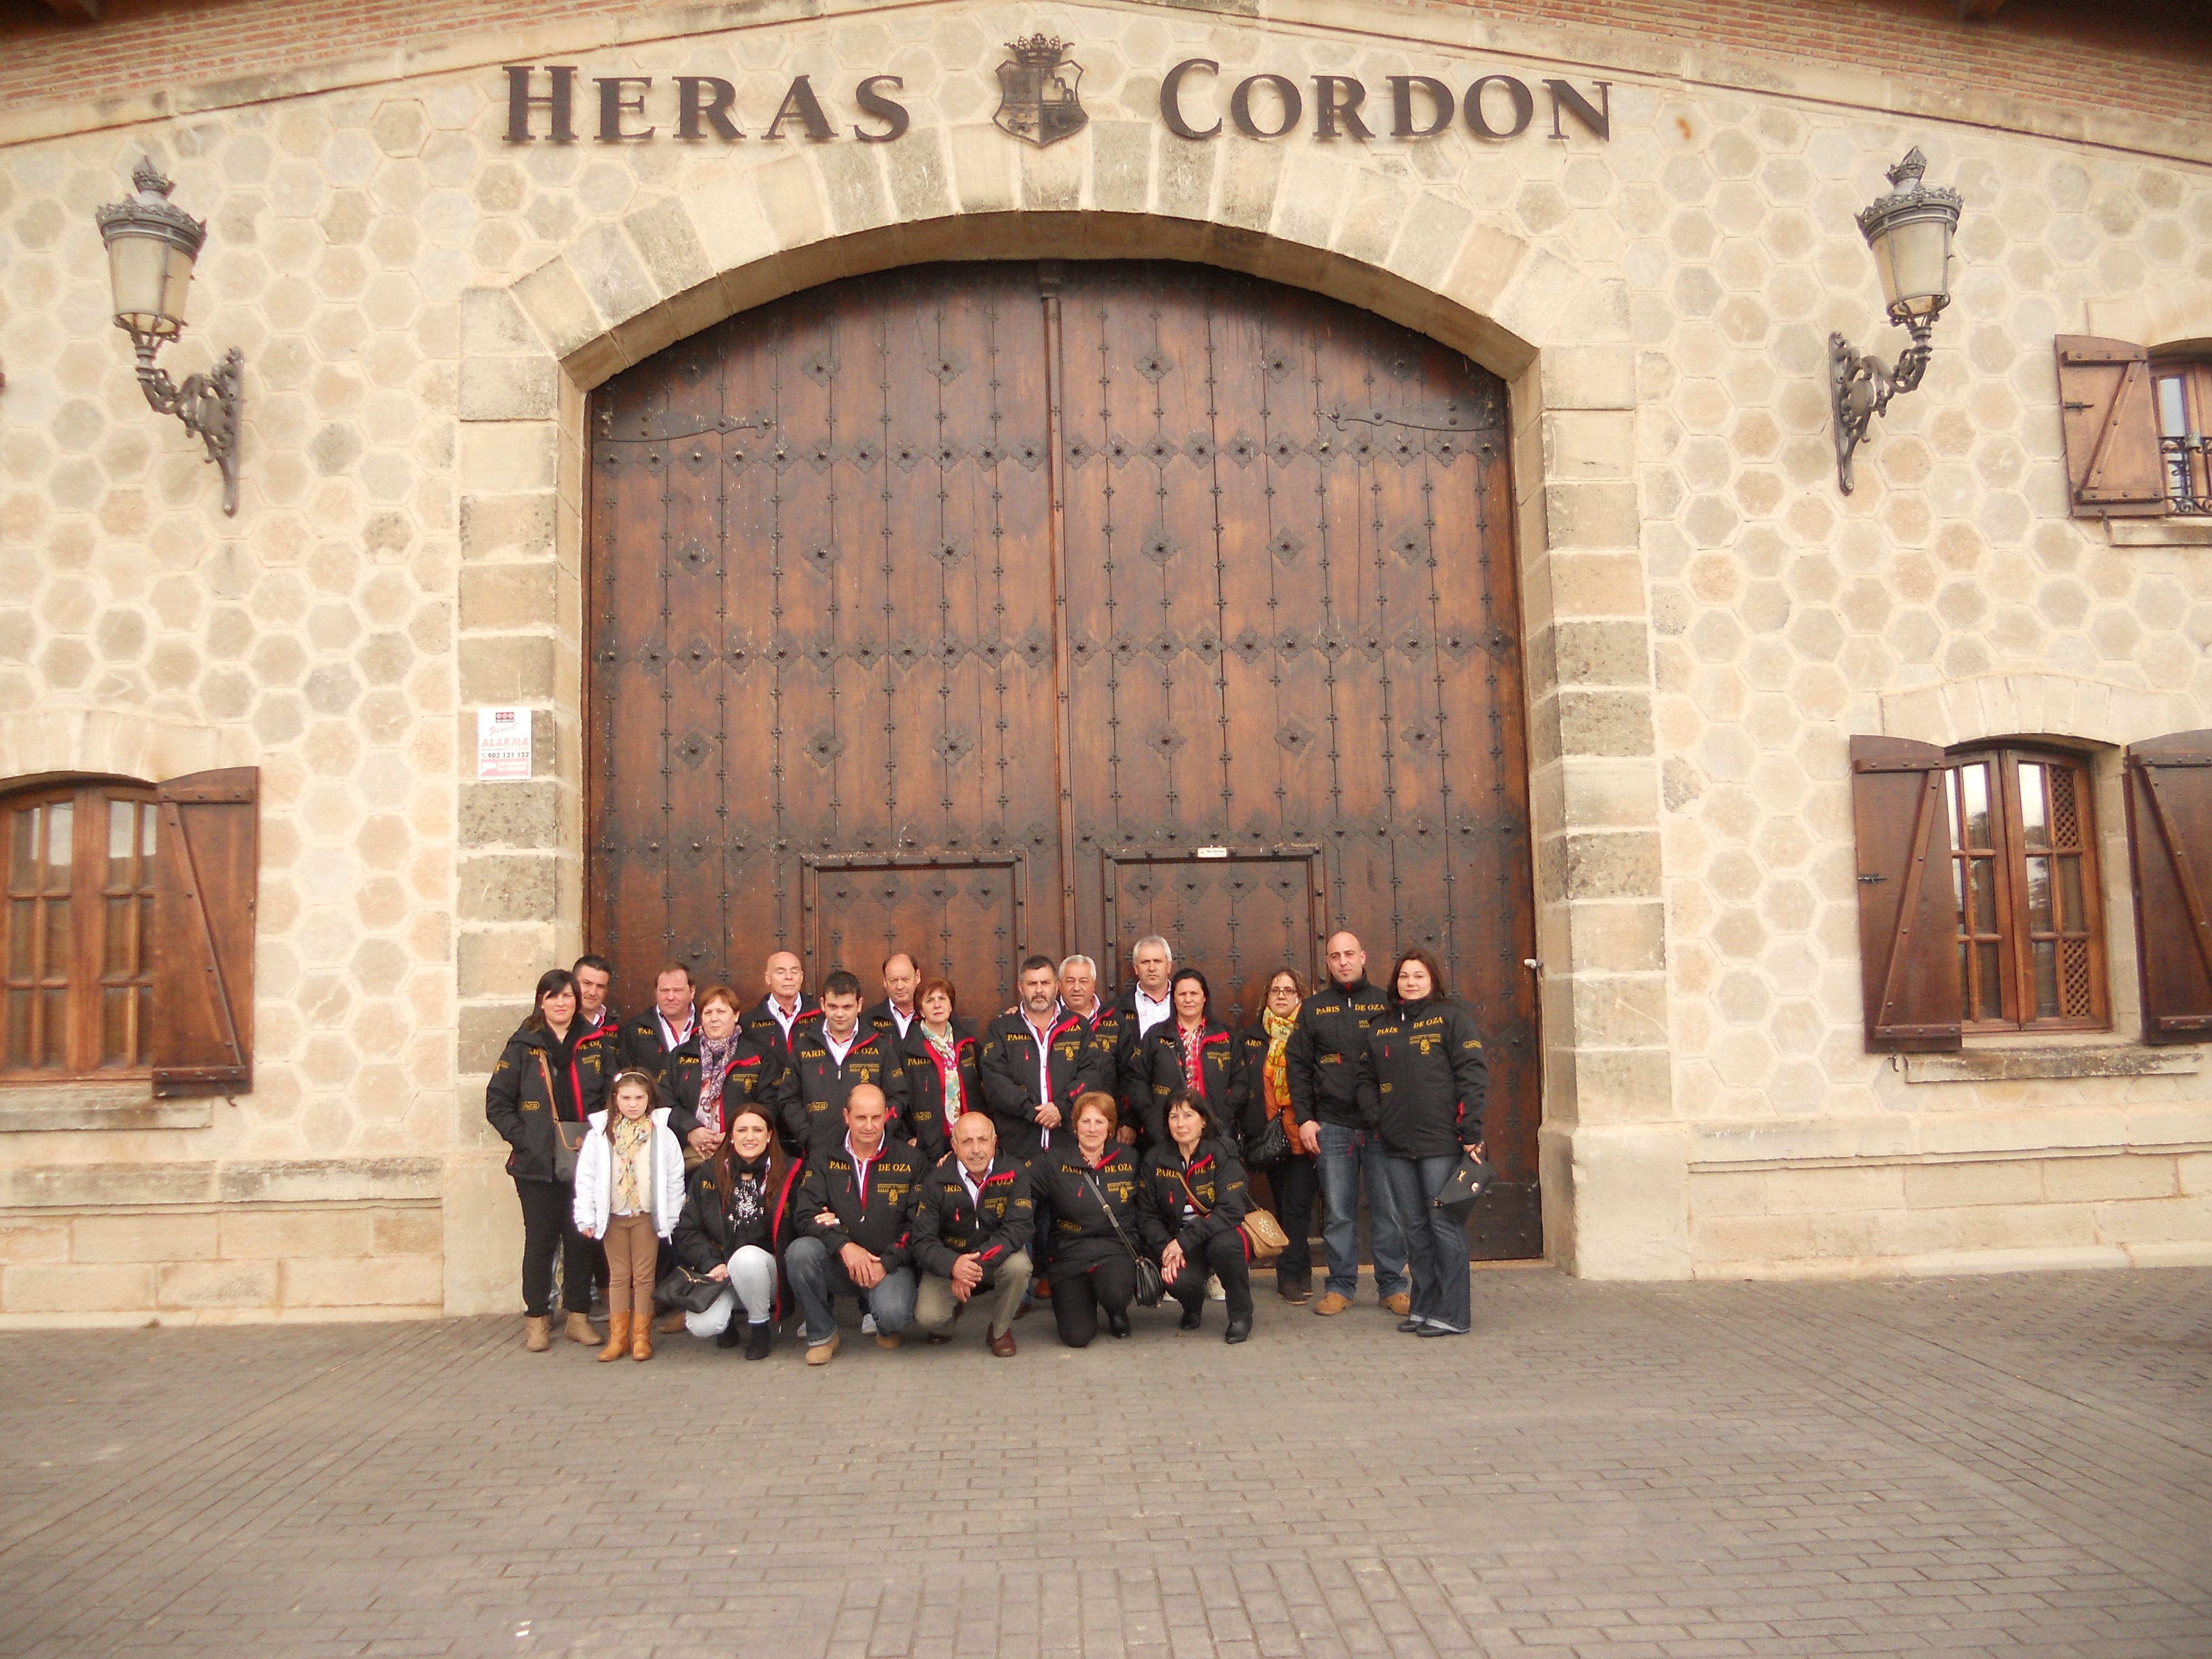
[484,969,606,1354]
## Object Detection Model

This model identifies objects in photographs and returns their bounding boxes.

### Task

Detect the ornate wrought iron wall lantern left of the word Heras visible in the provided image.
[97,157,246,515]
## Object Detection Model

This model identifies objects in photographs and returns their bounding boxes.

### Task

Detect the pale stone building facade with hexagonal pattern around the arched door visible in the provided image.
[0,0,2212,1323]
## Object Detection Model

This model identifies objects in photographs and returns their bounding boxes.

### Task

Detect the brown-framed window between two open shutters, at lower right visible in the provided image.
[1944,748,2112,1035]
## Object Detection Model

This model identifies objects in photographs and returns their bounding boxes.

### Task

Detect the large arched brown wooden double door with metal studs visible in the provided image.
[586,263,1540,1256]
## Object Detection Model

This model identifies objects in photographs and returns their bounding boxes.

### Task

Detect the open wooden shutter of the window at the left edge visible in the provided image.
[153,768,261,1095]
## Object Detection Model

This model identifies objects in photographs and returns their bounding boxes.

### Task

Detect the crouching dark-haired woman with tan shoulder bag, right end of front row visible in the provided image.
[1137,1088,1252,1343]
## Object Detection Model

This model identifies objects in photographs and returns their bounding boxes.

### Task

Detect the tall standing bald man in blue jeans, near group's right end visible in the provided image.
[1283,933,1413,1318]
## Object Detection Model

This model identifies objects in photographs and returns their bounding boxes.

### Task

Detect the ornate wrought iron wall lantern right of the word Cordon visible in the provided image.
[1827,146,1960,495]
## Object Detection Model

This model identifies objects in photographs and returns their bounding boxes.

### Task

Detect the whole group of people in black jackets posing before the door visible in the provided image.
[484,933,1489,1365]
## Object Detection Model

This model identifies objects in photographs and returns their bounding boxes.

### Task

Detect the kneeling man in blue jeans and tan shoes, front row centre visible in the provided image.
[783,1084,922,1365]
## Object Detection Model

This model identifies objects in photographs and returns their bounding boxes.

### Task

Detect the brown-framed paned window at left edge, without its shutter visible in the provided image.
[0,781,157,1082]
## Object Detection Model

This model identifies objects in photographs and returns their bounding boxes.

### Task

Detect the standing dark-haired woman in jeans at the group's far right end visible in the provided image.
[1358,947,1491,1336]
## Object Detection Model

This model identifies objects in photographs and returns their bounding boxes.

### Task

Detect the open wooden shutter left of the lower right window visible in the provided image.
[1851,737,1962,1053]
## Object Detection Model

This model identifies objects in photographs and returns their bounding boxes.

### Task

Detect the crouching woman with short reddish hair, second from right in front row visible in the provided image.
[1035,1091,1137,1347]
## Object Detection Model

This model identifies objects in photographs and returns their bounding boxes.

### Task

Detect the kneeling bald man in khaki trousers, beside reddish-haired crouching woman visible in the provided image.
[911,1113,1037,1360]
